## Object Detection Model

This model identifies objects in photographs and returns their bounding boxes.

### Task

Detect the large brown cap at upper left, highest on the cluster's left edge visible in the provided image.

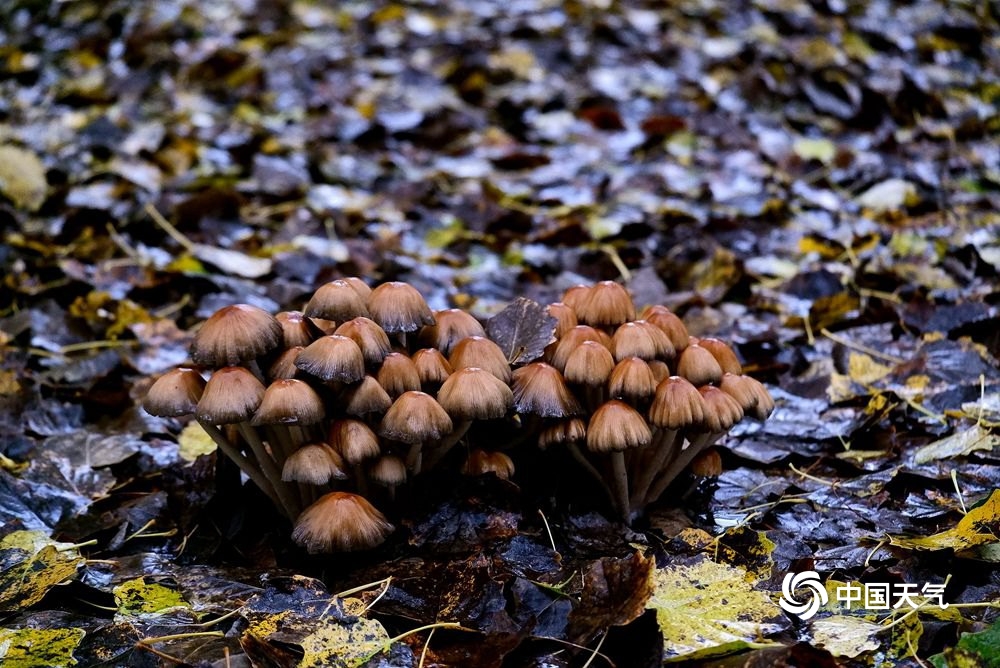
[191,304,284,367]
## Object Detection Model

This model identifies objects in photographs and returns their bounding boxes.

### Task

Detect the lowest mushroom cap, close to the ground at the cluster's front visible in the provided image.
[292,492,393,554]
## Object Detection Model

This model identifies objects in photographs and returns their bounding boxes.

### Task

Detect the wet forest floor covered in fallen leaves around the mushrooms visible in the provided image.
[0,0,1000,668]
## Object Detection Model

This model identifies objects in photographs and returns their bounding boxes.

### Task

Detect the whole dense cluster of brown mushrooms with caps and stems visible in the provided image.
[144,278,774,553]
